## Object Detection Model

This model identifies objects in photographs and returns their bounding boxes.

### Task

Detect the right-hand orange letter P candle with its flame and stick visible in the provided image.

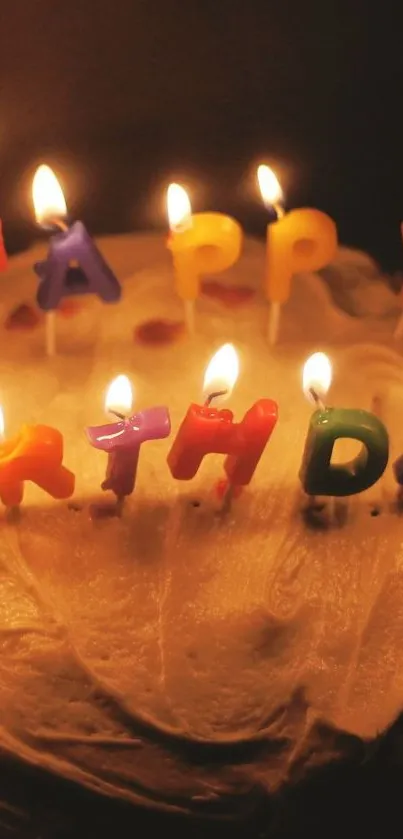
[257,165,337,345]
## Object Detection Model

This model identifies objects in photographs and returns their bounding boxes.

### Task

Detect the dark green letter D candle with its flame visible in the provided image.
[300,353,389,496]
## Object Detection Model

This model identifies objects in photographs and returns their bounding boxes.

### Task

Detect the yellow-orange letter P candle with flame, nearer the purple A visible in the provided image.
[167,184,242,332]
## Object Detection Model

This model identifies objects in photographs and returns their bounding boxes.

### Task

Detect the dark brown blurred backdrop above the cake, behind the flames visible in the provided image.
[0,0,403,269]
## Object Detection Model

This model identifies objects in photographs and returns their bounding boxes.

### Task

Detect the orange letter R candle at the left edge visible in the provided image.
[0,408,75,507]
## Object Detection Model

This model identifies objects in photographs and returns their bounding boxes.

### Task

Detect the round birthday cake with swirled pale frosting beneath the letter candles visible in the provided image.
[0,235,403,839]
